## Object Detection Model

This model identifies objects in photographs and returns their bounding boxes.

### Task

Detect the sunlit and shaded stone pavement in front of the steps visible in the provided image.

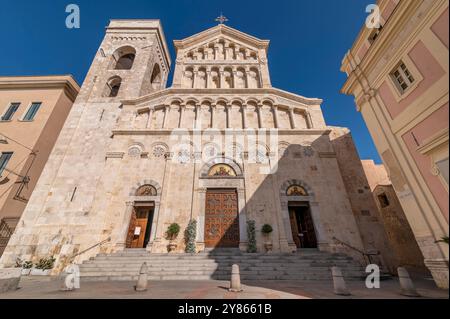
[0,277,449,299]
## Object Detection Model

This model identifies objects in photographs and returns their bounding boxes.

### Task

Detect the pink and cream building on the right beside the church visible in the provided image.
[341,0,449,288]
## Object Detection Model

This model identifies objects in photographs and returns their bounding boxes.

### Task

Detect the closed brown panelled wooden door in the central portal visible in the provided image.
[205,189,239,248]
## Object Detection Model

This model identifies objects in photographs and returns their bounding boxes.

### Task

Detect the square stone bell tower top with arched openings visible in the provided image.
[79,20,171,103]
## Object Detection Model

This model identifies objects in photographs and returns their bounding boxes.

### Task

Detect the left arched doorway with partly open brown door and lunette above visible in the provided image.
[126,185,157,248]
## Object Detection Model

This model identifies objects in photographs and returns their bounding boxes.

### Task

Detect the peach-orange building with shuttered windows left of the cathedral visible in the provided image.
[0,75,80,256]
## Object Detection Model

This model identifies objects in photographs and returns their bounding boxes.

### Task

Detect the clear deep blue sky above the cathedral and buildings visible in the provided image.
[0,0,380,162]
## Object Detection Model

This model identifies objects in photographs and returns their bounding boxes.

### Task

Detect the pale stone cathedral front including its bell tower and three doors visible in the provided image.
[0,20,394,272]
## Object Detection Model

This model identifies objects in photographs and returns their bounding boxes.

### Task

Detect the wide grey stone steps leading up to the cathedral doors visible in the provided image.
[80,249,364,281]
